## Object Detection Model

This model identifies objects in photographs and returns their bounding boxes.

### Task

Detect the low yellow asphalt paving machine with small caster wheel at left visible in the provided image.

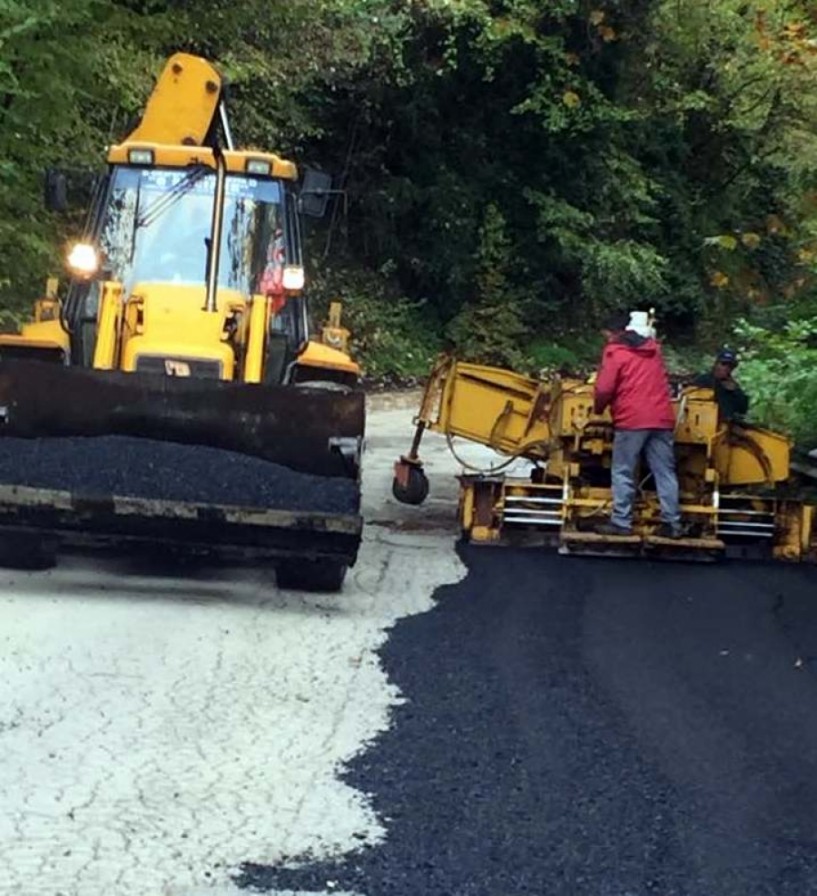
[392,348,817,561]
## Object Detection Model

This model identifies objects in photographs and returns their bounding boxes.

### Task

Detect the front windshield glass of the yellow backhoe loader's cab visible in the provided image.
[99,167,283,295]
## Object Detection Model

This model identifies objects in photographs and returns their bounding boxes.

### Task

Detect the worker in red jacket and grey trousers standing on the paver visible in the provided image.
[594,312,683,538]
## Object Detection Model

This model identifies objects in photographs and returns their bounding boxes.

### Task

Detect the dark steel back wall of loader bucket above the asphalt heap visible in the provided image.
[0,361,365,479]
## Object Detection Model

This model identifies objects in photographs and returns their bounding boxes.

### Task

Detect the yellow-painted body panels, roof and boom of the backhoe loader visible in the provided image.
[0,53,360,382]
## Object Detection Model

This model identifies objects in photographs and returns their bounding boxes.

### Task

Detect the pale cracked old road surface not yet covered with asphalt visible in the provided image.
[0,399,498,896]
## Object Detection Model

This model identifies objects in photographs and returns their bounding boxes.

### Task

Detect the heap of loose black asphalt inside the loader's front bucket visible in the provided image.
[0,436,359,513]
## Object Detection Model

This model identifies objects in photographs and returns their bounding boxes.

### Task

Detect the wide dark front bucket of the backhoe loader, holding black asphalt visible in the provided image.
[0,361,365,590]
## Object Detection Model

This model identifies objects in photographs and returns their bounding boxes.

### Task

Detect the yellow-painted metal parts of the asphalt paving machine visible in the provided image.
[417,358,817,559]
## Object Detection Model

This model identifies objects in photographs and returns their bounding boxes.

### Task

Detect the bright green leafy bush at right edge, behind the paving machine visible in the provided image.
[736,317,817,448]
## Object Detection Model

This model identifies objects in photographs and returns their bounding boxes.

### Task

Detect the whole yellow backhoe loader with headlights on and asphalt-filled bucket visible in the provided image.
[0,53,365,591]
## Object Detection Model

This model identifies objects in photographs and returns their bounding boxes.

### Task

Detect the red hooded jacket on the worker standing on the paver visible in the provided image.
[595,330,675,429]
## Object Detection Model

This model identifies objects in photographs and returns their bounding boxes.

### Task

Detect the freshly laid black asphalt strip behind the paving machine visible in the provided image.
[237,547,817,896]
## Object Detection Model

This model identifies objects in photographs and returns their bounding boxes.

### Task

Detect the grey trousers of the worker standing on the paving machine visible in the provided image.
[610,429,681,529]
